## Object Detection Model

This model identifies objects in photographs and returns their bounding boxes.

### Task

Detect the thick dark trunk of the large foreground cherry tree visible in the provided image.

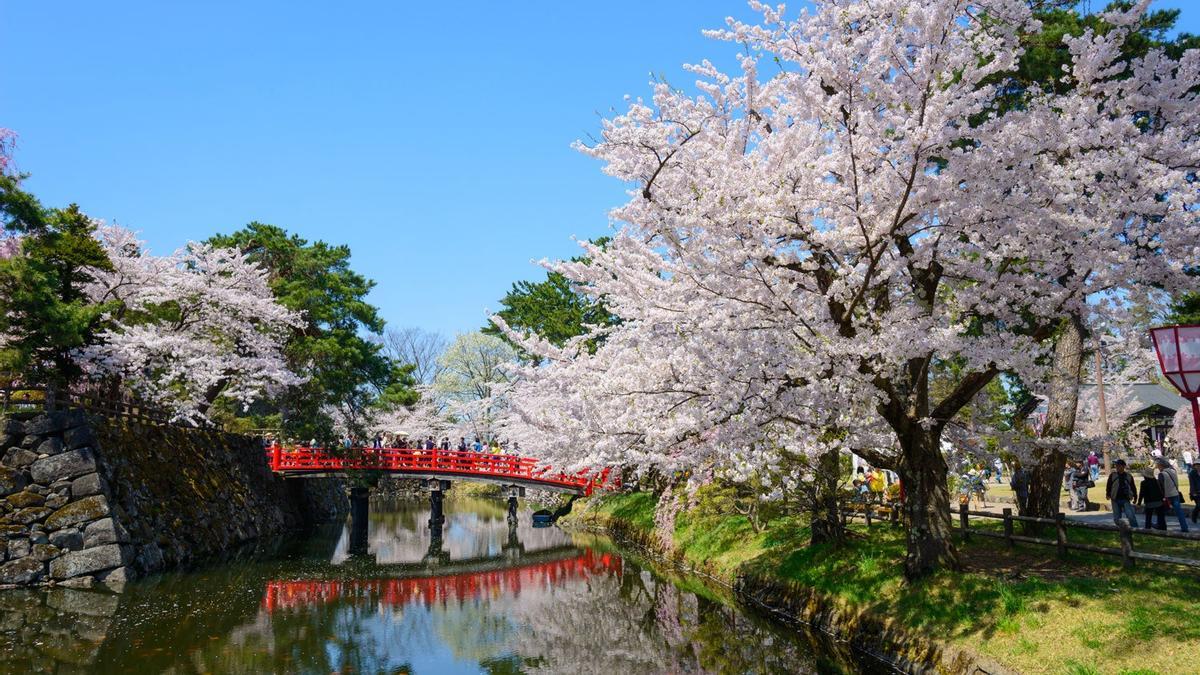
[896,423,959,580]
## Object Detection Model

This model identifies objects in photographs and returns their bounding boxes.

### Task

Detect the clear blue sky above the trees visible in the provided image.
[0,0,1200,334]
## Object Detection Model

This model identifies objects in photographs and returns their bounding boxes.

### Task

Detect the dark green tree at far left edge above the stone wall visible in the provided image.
[0,175,110,387]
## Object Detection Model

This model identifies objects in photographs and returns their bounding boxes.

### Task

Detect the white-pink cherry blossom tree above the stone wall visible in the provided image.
[78,227,304,422]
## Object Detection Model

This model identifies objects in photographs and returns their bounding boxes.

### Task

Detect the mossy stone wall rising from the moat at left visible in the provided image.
[0,411,347,587]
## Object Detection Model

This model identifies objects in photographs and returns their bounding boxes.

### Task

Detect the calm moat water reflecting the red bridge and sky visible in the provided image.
[0,498,877,675]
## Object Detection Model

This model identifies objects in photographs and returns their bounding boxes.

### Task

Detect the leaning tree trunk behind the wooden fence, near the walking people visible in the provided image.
[1021,315,1084,532]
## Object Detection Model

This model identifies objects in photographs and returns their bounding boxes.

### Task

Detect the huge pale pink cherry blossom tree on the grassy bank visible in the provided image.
[502,0,1200,577]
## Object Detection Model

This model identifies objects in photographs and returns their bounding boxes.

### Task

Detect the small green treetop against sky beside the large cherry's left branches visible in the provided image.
[484,238,617,359]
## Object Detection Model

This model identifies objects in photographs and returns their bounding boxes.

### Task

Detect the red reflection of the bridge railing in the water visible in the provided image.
[263,549,620,613]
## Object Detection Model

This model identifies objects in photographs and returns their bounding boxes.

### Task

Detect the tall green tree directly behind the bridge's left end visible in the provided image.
[209,222,418,440]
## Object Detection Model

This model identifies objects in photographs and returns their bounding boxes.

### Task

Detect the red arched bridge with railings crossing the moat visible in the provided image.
[266,446,614,495]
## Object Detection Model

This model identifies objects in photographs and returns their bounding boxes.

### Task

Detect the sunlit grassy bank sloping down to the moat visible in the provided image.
[575,494,1200,674]
